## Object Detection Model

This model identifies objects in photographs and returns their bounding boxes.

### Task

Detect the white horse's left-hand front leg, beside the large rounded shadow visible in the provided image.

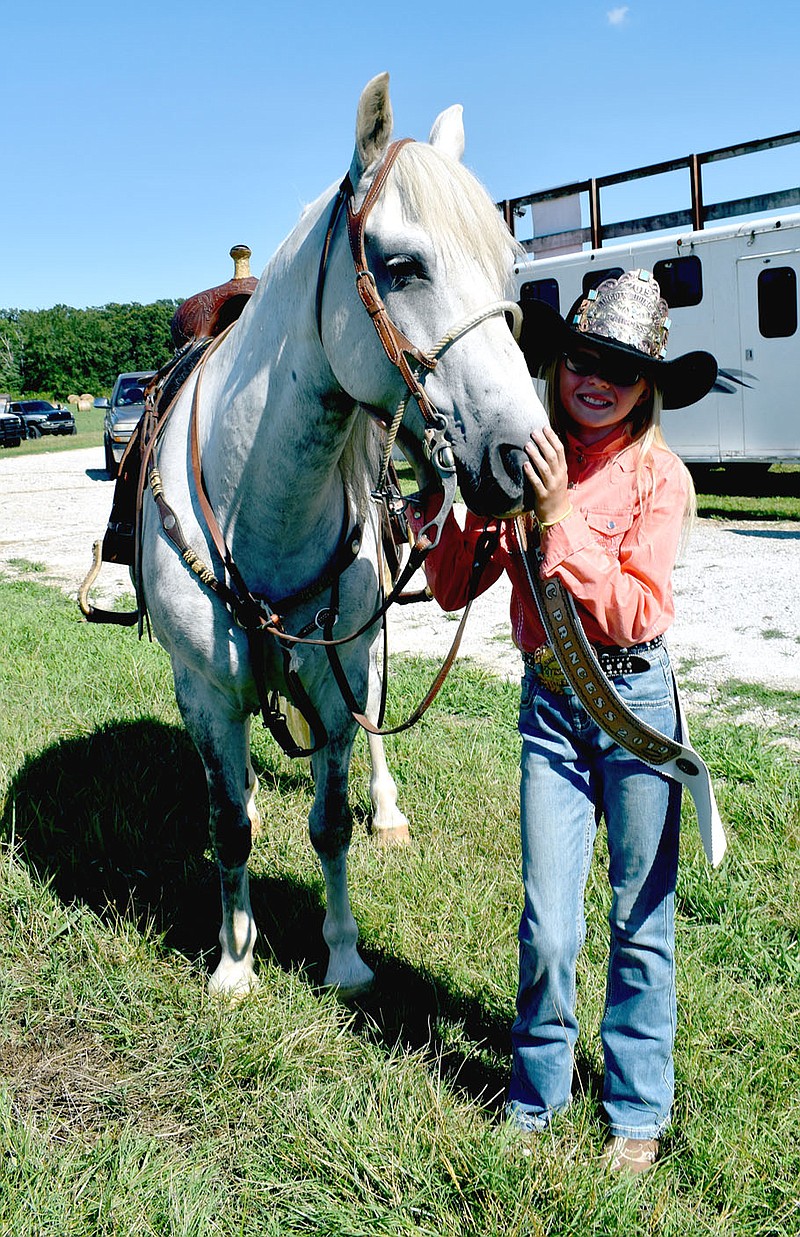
[173,667,257,996]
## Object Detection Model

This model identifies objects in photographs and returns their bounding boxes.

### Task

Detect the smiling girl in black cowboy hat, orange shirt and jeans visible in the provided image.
[409,271,717,1173]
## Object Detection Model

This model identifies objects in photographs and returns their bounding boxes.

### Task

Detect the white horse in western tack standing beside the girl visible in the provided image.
[141,74,545,995]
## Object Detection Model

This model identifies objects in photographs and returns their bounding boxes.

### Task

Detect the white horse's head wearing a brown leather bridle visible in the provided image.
[323,74,547,516]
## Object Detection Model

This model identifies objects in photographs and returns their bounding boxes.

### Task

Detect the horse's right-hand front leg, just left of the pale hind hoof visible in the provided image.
[308,742,375,997]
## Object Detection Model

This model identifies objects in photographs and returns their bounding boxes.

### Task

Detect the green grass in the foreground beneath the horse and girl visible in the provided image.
[0,581,800,1237]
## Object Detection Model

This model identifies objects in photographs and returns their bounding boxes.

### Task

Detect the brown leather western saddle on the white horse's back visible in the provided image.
[100,245,258,567]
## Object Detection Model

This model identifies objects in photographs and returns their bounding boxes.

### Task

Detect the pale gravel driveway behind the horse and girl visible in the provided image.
[0,448,800,691]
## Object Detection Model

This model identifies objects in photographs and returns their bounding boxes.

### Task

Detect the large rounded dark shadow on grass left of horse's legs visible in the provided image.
[2,721,219,956]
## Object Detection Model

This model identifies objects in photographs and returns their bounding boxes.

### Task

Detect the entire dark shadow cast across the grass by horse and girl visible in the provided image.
[0,721,600,1107]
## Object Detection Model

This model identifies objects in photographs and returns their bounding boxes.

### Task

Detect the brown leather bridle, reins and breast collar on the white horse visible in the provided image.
[150,139,521,756]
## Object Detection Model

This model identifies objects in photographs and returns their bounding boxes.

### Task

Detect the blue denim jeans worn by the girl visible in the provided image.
[508,646,680,1138]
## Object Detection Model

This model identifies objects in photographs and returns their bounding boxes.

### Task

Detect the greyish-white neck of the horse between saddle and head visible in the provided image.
[200,210,363,581]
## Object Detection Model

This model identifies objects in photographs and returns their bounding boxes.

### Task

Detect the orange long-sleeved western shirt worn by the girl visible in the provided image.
[408,426,689,652]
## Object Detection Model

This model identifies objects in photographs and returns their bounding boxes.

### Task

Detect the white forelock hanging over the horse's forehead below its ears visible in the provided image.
[394,142,522,292]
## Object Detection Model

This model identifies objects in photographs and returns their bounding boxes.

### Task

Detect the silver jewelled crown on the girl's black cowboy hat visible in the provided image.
[572,270,671,360]
